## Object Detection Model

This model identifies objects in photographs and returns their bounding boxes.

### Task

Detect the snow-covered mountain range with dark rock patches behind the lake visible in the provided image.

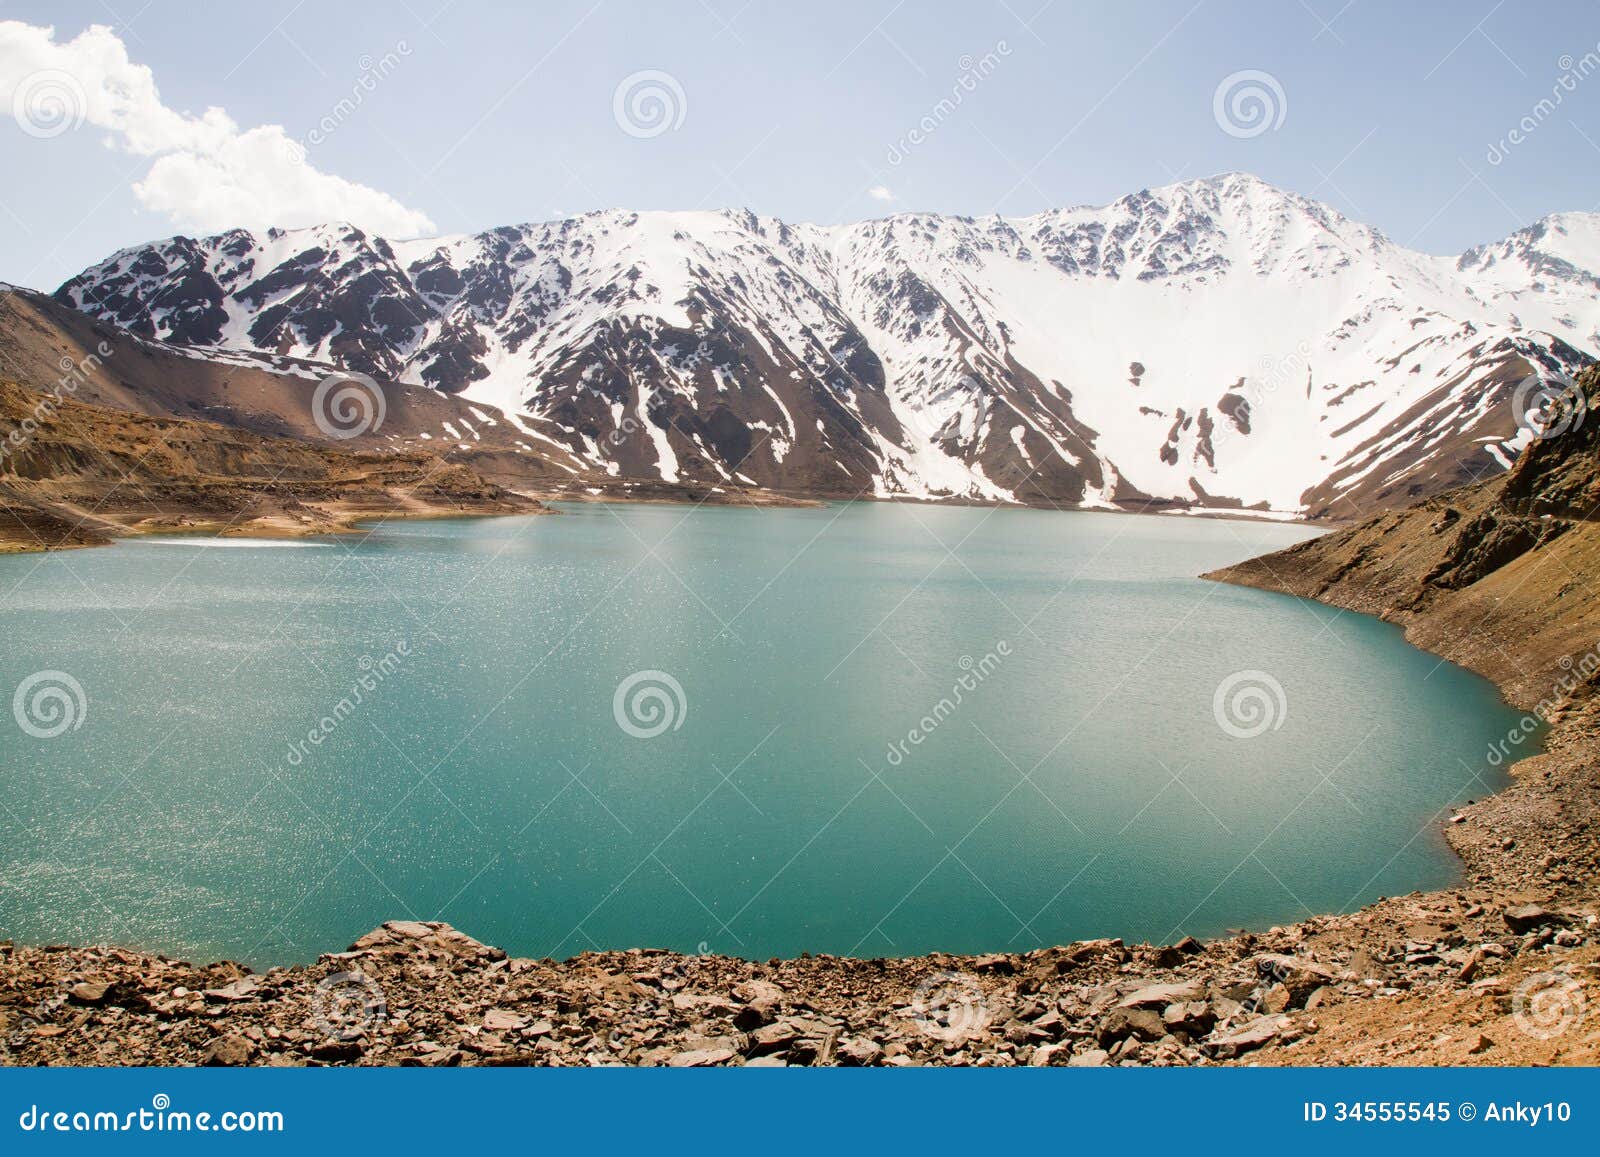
[56,173,1600,514]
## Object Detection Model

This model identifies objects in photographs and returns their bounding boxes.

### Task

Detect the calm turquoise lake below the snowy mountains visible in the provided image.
[0,504,1518,967]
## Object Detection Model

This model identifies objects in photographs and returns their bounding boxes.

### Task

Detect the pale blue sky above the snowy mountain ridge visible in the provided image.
[0,0,1600,288]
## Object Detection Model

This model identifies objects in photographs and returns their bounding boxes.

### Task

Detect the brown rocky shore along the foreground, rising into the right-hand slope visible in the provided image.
[0,371,1600,1066]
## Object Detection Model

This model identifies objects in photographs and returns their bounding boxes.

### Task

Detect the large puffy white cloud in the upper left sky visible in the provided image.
[0,21,435,237]
